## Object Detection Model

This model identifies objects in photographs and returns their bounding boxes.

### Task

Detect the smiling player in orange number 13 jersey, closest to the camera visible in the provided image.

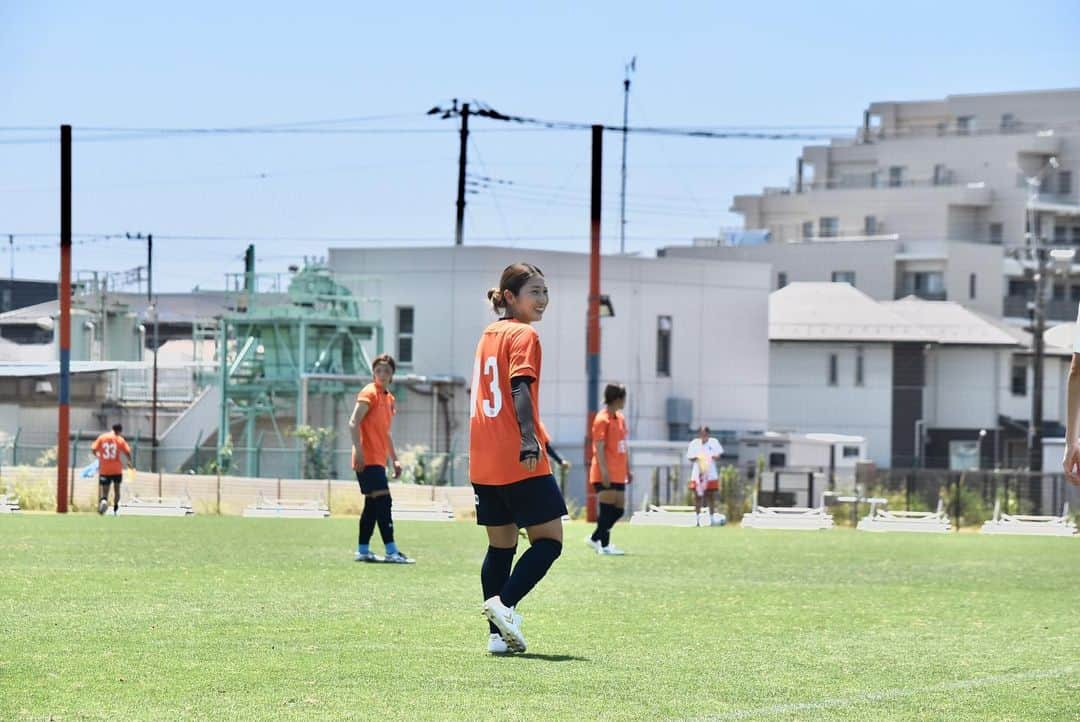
[469,263,566,654]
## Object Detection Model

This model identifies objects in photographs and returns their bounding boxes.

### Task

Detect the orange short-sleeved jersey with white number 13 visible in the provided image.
[469,319,551,486]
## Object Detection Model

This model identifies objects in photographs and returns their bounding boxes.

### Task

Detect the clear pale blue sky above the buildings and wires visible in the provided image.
[0,0,1080,290]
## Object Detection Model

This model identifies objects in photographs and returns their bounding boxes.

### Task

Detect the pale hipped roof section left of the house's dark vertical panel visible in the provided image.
[769,283,935,343]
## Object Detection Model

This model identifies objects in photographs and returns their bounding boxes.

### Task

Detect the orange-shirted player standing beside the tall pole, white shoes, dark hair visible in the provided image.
[585,383,631,556]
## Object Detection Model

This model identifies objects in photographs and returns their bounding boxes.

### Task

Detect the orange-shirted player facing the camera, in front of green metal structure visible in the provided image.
[349,354,415,564]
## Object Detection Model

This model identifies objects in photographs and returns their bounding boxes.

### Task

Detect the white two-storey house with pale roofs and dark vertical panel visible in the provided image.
[769,283,1070,468]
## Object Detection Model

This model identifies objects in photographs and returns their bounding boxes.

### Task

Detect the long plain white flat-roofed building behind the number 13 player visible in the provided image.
[329,247,770,496]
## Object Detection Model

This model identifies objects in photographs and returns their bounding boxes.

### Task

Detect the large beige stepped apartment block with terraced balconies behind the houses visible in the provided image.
[663,88,1080,325]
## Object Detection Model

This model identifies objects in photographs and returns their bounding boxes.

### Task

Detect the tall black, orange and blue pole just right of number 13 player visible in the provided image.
[584,125,604,521]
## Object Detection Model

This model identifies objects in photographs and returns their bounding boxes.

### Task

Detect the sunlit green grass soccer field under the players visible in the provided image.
[0,514,1080,720]
